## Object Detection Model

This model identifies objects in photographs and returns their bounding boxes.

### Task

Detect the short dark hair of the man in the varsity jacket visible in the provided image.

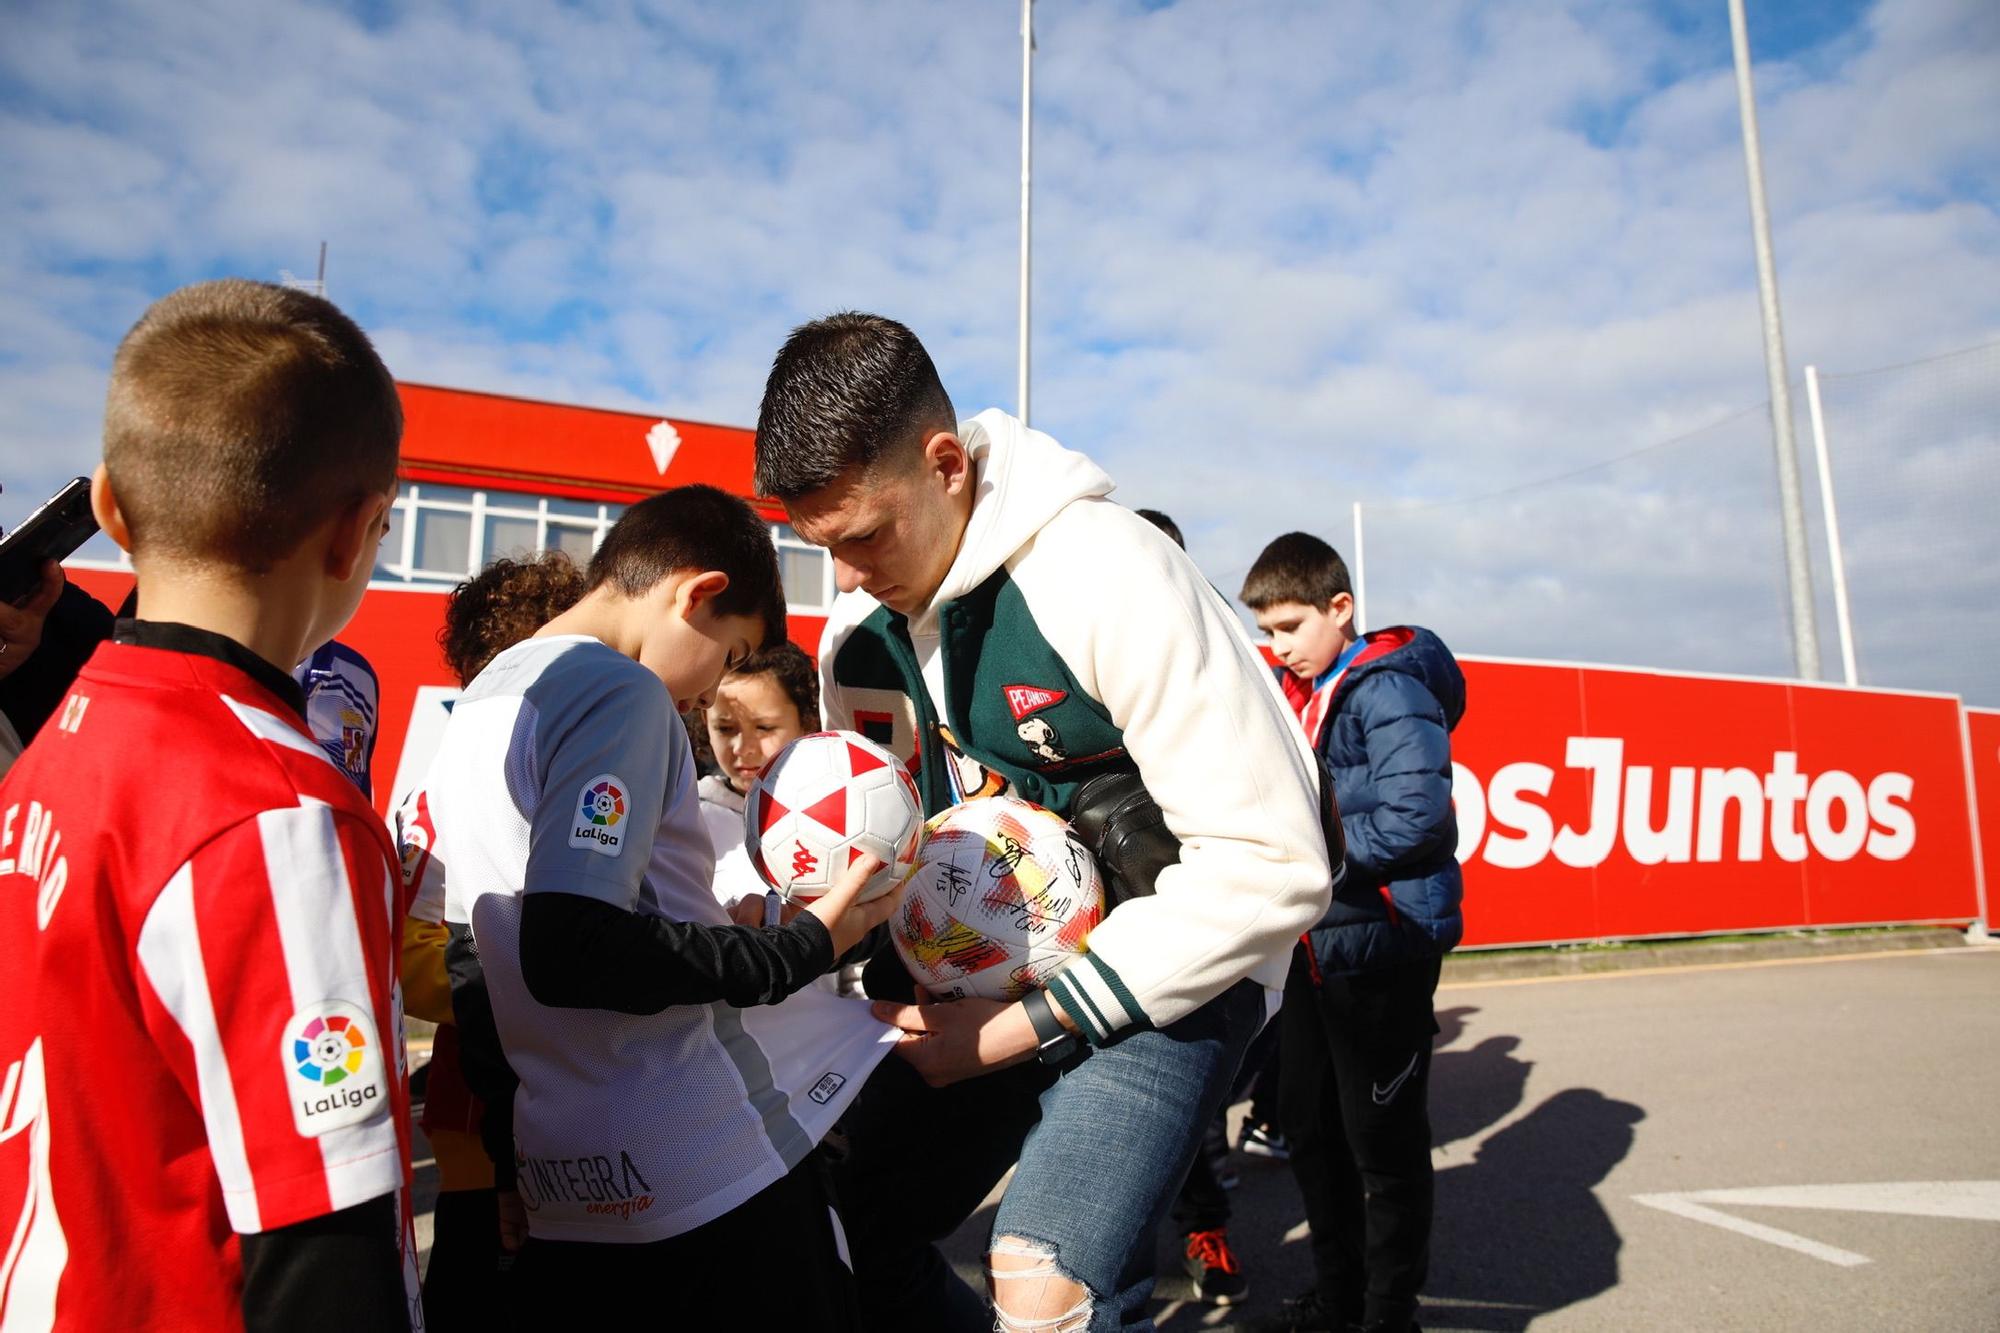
[756,310,958,500]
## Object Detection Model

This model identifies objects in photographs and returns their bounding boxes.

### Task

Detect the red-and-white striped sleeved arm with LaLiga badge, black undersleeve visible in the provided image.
[136,805,408,1304]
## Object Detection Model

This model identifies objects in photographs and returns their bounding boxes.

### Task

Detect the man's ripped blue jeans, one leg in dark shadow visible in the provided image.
[838,981,1264,1333]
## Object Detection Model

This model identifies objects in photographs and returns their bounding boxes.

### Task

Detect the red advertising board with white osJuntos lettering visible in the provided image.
[1452,658,1978,947]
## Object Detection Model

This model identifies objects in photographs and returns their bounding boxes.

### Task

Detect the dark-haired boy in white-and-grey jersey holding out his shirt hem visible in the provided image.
[424,486,896,1329]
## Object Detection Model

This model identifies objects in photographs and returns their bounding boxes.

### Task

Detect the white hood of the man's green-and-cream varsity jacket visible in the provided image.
[910,408,1118,634]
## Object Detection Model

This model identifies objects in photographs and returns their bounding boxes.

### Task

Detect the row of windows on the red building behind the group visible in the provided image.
[374,482,834,614]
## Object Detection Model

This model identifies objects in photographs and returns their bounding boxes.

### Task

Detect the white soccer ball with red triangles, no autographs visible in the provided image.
[744,731,924,903]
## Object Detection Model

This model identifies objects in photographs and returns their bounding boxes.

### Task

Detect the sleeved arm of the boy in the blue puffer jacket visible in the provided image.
[1328,671,1452,883]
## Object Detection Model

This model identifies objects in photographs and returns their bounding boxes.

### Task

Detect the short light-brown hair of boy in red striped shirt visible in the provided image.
[104,278,402,572]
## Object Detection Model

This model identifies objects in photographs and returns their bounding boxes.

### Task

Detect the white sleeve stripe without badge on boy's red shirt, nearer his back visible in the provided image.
[138,865,260,1233]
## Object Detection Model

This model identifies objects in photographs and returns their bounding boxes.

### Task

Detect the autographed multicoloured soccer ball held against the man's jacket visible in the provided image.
[890,797,1104,1001]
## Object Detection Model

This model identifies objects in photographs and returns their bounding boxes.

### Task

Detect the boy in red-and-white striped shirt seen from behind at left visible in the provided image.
[0,280,416,1329]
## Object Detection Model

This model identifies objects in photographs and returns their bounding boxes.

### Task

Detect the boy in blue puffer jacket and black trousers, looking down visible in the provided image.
[1242,532,1466,1333]
